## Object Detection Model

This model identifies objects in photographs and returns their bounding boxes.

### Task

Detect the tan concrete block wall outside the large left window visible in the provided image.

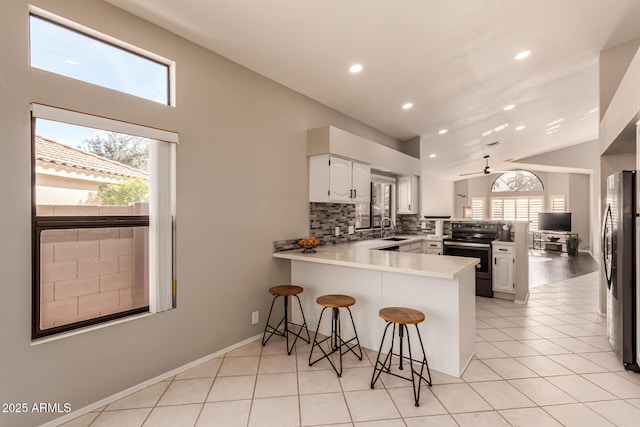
[37,206,149,329]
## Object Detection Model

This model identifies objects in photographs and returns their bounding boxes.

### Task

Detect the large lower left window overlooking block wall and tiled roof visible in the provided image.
[32,104,177,338]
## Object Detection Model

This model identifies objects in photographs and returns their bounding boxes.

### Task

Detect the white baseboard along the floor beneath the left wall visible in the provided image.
[40,333,262,427]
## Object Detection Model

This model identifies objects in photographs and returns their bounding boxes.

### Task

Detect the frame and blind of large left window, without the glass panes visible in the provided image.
[30,107,178,340]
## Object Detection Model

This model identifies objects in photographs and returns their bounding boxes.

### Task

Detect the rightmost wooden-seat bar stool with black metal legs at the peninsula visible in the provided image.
[371,307,431,406]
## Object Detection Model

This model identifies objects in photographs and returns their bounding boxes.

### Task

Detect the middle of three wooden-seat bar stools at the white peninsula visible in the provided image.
[309,295,362,376]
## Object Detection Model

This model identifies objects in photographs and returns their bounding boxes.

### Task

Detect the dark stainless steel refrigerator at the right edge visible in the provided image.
[602,171,640,371]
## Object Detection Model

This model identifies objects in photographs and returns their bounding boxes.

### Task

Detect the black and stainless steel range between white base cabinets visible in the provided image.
[443,221,499,298]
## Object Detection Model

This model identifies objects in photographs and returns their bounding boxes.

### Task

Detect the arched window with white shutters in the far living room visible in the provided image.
[491,169,544,231]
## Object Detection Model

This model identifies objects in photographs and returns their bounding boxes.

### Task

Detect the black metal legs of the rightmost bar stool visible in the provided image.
[371,322,431,406]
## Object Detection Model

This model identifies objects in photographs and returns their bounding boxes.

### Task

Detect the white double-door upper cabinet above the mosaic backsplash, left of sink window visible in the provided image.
[309,155,371,203]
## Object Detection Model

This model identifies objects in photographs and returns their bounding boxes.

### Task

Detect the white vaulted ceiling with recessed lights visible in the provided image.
[107,0,640,179]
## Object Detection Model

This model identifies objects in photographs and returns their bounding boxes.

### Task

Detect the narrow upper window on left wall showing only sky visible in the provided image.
[29,11,170,104]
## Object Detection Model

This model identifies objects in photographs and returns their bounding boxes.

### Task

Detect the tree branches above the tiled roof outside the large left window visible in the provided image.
[82,132,149,171]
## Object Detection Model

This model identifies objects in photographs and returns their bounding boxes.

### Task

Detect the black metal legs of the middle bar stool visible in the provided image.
[309,307,362,377]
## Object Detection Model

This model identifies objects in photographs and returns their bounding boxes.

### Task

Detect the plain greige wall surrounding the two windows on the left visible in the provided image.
[0,0,401,426]
